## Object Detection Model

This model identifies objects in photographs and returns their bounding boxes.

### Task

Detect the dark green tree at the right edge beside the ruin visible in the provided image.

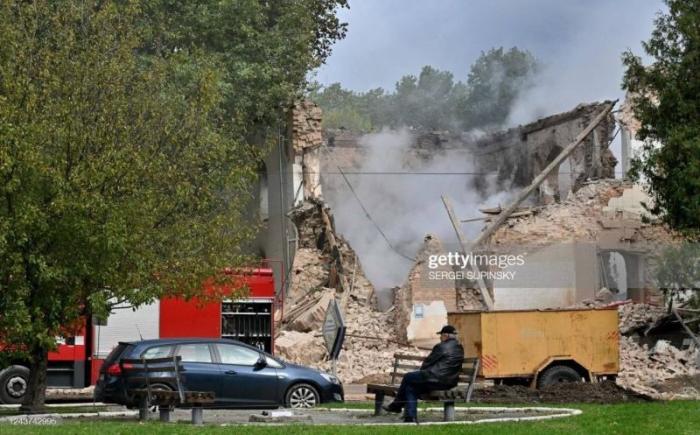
[623,0,700,237]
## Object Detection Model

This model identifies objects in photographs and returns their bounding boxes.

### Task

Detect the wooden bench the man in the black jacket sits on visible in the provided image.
[367,353,479,421]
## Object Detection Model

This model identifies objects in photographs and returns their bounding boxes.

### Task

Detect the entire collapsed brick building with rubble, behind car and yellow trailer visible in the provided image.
[277,97,698,398]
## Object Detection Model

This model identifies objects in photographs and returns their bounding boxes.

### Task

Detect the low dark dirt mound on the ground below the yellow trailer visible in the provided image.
[472,381,651,403]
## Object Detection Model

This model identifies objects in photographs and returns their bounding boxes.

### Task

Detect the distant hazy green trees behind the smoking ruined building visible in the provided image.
[310,47,539,132]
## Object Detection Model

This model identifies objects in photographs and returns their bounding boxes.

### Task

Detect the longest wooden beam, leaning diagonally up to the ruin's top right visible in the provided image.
[472,100,617,247]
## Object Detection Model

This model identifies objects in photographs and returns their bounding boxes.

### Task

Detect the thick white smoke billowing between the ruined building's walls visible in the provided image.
[324,129,509,289]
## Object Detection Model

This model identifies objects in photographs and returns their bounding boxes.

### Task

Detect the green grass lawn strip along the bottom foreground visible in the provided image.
[0,401,700,435]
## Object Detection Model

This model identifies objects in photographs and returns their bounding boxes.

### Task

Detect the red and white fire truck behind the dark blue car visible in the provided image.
[0,268,282,403]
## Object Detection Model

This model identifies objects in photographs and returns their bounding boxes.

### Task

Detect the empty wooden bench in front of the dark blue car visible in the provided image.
[119,356,214,425]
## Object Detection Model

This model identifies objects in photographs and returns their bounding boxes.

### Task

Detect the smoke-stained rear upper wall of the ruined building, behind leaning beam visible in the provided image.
[321,101,617,204]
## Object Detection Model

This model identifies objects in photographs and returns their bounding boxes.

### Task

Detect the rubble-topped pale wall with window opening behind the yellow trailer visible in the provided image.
[491,180,681,308]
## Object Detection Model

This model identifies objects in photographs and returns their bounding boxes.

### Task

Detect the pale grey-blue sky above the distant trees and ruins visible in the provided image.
[315,0,664,111]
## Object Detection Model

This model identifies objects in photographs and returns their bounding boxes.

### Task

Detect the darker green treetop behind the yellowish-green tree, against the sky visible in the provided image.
[141,0,347,133]
